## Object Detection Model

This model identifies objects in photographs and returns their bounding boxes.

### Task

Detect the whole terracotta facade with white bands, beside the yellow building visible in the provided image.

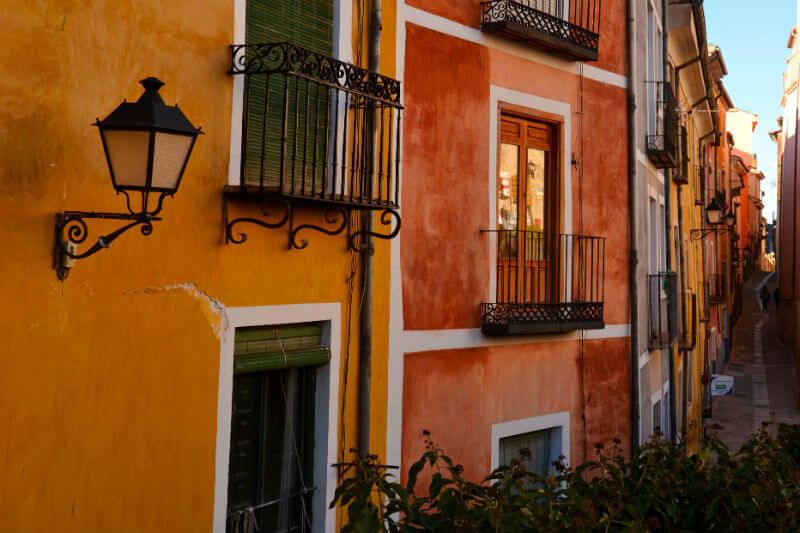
[389,0,631,479]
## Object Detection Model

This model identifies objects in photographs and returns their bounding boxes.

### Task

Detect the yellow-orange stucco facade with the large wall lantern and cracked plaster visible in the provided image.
[0,0,395,532]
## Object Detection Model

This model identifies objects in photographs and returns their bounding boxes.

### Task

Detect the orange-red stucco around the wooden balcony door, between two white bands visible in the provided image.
[401,23,628,329]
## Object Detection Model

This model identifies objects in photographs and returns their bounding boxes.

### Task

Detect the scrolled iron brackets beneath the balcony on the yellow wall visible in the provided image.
[222,188,401,252]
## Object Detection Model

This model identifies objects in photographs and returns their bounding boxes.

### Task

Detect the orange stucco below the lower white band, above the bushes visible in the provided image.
[401,339,630,480]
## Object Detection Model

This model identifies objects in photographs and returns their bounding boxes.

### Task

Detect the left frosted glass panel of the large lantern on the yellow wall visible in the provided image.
[102,129,150,189]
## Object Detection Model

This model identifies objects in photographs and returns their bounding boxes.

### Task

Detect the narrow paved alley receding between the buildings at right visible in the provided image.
[705,272,800,450]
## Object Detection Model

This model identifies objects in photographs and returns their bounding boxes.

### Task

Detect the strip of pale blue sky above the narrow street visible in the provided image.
[704,0,797,221]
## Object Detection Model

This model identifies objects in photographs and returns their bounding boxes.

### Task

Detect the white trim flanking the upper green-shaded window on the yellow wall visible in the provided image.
[228,0,353,185]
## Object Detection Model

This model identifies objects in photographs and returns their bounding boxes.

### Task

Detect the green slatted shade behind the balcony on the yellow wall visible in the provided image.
[244,0,333,192]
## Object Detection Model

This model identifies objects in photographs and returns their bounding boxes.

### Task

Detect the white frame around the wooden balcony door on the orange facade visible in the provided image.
[484,85,572,302]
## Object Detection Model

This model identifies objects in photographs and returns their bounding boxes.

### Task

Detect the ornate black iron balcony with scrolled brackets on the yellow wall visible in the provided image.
[226,43,402,248]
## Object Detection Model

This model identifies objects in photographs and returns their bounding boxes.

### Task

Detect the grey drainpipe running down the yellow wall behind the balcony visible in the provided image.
[358,0,382,455]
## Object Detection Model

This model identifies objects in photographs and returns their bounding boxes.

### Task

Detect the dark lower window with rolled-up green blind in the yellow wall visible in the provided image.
[227,323,330,533]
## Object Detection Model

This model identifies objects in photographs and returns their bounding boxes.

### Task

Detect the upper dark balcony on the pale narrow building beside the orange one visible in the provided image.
[647,81,680,168]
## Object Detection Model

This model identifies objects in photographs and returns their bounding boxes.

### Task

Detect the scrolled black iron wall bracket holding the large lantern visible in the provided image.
[53,191,173,281]
